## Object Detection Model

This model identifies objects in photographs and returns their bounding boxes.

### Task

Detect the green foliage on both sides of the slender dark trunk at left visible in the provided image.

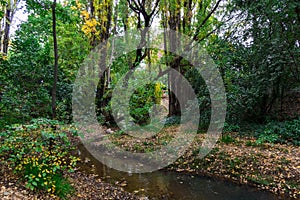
[0,1,89,125]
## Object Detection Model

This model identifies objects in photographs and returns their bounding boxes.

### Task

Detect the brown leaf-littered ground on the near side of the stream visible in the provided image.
[0,162,142,200]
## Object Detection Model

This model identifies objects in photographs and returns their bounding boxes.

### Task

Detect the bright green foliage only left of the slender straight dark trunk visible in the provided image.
[0,13,51,125]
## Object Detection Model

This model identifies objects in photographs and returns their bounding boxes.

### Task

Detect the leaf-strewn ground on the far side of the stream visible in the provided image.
[102,126,300,199]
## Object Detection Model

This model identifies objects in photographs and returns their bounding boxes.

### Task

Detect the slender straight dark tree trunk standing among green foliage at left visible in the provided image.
[52,0,58,119]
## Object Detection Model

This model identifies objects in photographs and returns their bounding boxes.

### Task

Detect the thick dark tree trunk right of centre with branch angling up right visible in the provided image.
[165,0,221,116]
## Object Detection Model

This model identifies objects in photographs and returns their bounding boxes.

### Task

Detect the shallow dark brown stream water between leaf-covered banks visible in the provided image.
[79,146,278,200]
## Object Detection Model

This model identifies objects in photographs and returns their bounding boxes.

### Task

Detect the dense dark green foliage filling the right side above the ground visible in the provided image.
[223,0,300,122]
